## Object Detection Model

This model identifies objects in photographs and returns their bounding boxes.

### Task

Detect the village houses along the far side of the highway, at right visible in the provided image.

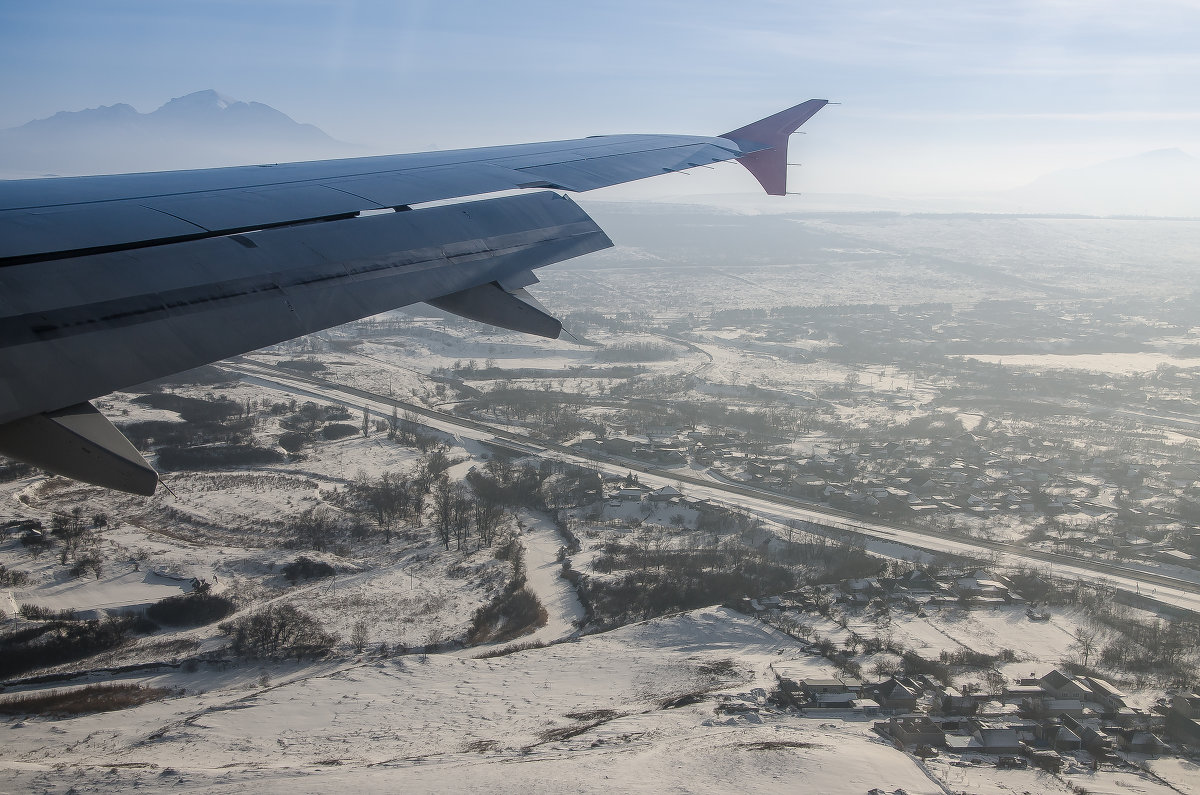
[578,428,1200,568]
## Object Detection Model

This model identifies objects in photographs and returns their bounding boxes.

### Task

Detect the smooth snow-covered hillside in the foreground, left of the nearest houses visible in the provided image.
[0,609,941,794]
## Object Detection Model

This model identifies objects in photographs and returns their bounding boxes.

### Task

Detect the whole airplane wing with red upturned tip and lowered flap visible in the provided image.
[0,100,827,495]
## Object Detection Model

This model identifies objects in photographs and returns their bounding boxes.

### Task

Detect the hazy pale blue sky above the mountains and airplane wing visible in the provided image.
[0,0,1200,192]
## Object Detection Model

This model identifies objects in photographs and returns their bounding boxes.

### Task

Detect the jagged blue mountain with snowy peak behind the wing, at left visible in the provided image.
[0,89,360,178]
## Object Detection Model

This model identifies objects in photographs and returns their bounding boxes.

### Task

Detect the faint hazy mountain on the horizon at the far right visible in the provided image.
[1003,149,1200,216]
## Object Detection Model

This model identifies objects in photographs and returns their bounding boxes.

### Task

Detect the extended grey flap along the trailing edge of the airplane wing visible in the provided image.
[0,192,612,423]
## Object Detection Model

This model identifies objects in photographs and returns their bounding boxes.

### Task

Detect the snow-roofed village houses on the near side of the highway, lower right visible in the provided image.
[746,572,1200,772]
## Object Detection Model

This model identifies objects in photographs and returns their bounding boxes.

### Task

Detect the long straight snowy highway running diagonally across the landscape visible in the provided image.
[221,357,1200,614]
